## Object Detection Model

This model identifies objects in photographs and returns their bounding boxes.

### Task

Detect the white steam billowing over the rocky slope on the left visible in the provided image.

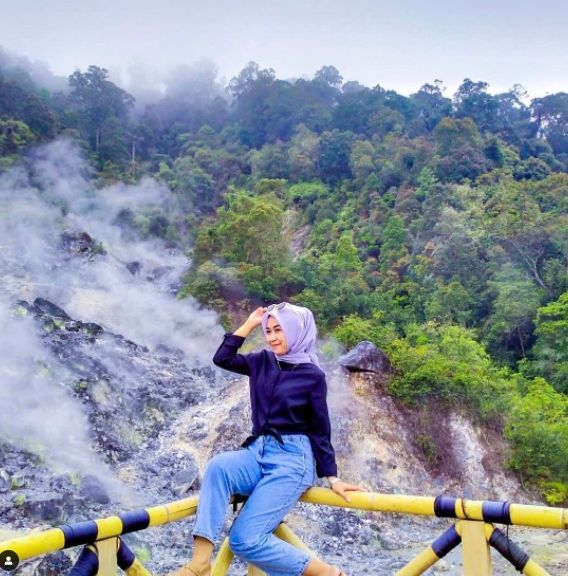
[0,140,221,482]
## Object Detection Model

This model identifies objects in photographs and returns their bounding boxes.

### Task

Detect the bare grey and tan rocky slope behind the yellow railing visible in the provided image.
[0,299,562,576]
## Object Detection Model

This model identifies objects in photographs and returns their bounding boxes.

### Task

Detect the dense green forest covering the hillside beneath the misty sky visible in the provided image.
[0,52,568,505]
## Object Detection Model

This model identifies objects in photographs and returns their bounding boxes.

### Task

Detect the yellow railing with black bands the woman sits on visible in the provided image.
[0,488,568,576]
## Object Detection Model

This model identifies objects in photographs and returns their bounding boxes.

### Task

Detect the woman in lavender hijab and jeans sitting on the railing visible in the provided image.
[176,302,361,576]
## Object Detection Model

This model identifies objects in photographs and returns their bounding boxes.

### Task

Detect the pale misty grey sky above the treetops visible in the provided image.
[0,0,568,97]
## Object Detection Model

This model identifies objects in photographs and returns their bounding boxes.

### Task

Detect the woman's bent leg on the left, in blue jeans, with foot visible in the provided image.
[175,447,261,576]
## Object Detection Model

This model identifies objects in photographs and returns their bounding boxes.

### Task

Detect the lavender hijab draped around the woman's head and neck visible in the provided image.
[262,302,319,366]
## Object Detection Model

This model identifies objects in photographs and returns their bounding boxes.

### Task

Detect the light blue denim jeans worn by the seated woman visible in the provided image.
[193,434,314,576]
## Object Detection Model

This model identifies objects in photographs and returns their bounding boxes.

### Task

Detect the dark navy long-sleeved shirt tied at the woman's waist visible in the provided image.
[213,334,337,478]
